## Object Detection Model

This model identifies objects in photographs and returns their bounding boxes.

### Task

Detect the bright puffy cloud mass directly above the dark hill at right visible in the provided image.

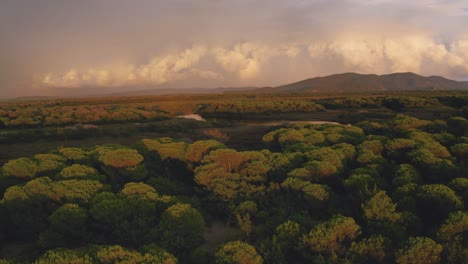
[308,35,468,77]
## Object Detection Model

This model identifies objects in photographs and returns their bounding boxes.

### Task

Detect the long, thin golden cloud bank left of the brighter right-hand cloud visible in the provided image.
[42,42,300,88]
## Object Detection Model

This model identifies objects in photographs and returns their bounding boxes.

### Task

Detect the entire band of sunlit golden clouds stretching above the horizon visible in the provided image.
[42,33,468,88]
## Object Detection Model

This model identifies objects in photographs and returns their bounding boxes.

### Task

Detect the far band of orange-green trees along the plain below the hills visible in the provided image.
[0,91,468,128]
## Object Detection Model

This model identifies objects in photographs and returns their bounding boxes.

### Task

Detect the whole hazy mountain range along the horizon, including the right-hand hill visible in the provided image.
[4,72,468,101]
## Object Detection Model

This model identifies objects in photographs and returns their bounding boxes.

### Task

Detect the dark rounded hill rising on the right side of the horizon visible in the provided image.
[256,72,468,93]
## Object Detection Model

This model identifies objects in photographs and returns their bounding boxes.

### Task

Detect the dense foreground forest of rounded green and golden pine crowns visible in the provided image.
[0,115,468,263]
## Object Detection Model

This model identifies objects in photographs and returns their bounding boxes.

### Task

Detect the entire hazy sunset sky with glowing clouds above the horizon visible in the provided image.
[0,0,468,98]
